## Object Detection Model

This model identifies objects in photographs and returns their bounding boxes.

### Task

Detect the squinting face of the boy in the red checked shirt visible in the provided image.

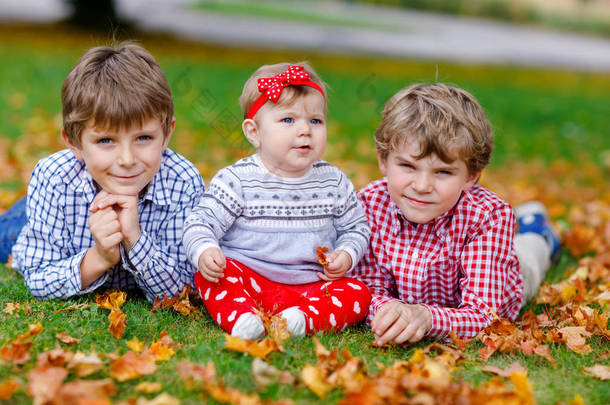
[379,141,479,224]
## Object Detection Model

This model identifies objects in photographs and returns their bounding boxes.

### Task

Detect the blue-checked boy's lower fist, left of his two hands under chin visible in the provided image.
[89,195,123,269]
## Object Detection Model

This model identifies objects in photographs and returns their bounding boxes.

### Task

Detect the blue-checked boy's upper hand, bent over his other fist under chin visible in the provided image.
[89,190,140,251]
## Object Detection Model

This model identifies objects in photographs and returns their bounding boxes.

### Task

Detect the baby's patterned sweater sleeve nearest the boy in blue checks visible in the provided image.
[182,167,244,268]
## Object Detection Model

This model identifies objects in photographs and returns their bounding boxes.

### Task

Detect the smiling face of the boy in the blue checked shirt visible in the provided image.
[62,119,175,195]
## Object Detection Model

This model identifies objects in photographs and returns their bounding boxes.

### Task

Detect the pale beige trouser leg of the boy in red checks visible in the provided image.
[515,233,551,305]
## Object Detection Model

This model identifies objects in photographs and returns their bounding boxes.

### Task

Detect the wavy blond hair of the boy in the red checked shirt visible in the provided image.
[375,83,493,174]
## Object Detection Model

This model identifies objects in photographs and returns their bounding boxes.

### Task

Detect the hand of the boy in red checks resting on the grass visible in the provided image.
[371,301,432,346]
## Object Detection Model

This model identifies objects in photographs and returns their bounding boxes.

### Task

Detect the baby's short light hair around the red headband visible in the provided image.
[239,62,327,119]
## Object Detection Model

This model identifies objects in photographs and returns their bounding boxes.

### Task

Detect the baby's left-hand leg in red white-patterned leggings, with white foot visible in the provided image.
[195,259,265,339]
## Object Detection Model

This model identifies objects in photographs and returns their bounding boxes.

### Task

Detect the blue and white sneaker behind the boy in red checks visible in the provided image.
[515,201,561,263]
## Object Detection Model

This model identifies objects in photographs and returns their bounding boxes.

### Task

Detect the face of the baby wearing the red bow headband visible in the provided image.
[242,92,326,177]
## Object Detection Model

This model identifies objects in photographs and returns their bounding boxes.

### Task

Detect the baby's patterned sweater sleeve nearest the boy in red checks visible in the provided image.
[333,173,371,270]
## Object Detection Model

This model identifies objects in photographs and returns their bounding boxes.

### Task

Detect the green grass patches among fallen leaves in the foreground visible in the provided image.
[0,265,610,405]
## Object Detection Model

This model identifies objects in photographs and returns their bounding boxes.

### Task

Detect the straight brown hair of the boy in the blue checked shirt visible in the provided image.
[61,43,174,146]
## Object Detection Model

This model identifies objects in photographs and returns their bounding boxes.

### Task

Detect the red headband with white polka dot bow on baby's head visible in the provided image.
[248,65,324,119]
